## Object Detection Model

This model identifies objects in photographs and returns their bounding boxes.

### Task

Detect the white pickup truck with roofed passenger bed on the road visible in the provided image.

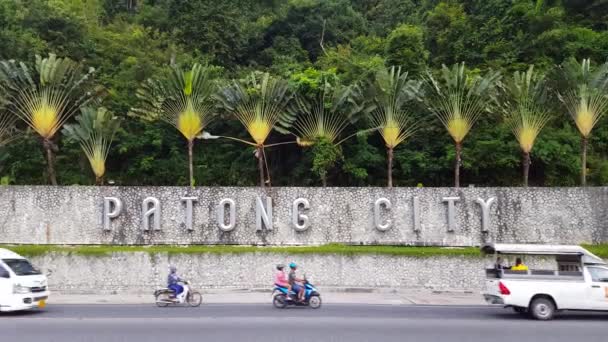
[481,244,608,320]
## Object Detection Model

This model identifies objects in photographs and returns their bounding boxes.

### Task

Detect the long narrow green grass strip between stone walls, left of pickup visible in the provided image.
[0,244,480,257]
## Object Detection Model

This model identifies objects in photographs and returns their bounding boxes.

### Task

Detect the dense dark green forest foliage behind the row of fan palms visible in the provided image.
[0,0,608,186]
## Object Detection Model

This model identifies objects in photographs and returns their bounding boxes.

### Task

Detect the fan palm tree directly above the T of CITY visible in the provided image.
[425,62,500,188]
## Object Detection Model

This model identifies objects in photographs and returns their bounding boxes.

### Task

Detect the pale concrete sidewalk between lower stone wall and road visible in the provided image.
[48,288,484,305]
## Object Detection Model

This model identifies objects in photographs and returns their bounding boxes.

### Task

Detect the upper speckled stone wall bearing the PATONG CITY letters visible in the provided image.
[0,186,608,246]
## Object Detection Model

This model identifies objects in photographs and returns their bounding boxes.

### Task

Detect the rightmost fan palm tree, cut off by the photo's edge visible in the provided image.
[558,59,608,186]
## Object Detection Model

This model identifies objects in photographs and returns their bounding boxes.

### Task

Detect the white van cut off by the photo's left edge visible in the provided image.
[0,248,49,311]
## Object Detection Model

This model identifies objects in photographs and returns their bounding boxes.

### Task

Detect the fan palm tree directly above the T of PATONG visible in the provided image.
[131,64,216,186]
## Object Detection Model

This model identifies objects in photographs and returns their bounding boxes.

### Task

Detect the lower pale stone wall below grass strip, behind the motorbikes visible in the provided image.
[30,252,555,294]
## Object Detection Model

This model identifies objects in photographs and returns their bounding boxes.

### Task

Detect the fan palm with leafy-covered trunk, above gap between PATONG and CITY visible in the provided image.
[291,80,364,186]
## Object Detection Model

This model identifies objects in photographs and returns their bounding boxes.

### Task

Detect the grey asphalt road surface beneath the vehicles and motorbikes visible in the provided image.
[0,304,608,342]
